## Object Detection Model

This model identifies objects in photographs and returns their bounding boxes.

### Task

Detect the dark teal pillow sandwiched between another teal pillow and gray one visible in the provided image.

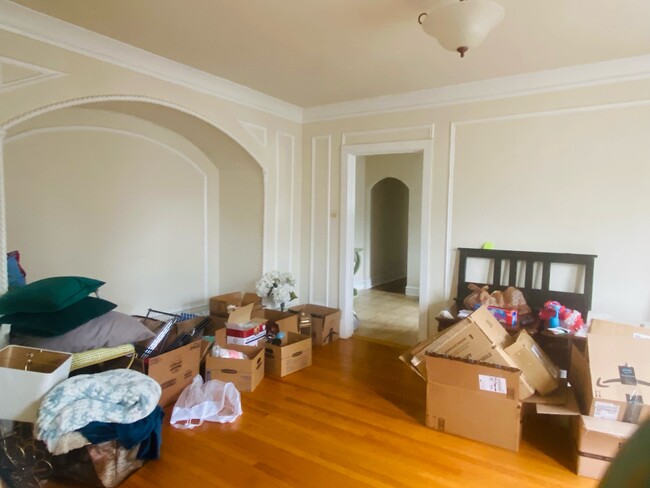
[2,297,117,337]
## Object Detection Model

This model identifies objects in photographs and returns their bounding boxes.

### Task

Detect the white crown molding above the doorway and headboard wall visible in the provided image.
[303,55,650,123]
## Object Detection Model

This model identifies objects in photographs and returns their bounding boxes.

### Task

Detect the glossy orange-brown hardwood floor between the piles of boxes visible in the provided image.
[47,339,597,488]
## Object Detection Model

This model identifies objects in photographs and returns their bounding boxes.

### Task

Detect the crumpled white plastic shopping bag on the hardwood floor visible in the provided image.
[169,374,242,429]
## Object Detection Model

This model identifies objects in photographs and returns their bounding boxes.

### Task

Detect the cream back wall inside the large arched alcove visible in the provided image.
[4,109,219,314]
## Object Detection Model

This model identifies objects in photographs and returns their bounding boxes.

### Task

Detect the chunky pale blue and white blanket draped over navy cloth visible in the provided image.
[34,369,161,452]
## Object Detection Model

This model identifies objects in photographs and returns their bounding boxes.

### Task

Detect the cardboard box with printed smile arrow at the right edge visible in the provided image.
[569,334,650,424]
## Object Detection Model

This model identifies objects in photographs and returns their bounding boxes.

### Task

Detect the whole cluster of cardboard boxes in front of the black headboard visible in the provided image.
[400,307,650,479]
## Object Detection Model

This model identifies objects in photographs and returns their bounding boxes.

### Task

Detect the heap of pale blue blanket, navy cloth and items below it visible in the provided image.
[34,369,164,488]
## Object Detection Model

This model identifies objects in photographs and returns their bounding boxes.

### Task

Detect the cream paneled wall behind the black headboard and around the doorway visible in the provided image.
[304,80,650,329]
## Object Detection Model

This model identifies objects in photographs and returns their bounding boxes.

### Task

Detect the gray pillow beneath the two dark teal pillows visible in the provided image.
[11,311,155,352]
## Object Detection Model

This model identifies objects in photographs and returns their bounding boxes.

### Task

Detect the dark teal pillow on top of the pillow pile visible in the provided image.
[0,276,104,315]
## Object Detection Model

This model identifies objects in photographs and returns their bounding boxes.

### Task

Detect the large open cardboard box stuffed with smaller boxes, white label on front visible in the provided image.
[401,307,560,451]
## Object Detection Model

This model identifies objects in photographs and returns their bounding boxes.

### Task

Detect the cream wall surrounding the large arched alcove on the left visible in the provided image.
[0,30,305,306]
